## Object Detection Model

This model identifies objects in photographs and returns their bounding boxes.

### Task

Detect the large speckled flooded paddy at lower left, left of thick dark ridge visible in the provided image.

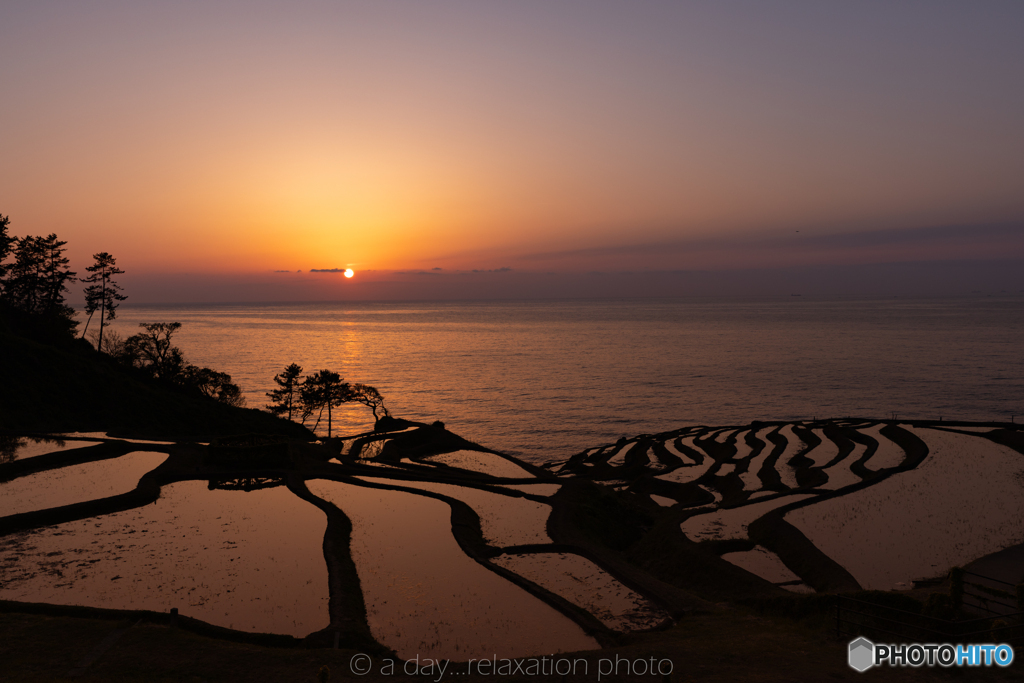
[0,481,330,637]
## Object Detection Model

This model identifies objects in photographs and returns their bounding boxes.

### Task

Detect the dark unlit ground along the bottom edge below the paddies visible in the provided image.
[9,608,1024,683]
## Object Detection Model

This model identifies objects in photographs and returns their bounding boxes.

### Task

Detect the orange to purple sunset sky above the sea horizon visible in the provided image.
[0,0,1024,301]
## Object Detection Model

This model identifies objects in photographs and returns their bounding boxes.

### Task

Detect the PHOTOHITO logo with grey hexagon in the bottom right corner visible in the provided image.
[847,638,1014,672]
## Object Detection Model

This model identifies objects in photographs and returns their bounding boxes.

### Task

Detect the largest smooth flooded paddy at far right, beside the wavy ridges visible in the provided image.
[785,427,1024,590]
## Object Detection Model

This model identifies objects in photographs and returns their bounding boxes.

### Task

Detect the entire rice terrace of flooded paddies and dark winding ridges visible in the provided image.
[0,417,1024,680]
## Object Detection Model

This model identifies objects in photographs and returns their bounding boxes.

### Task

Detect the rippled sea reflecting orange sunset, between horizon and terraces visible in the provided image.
[101,295,1024,464]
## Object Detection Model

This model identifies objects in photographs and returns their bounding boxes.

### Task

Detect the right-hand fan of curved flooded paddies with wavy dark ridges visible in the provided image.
[557,420,1024,591]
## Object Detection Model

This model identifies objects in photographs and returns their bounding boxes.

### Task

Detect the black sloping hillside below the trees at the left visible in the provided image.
[0,332,312,439]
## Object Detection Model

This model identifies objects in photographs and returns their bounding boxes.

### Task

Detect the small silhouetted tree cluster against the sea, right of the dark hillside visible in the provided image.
[266,362,390,437]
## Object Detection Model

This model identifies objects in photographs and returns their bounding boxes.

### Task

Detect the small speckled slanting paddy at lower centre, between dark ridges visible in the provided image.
[490,553,669,631]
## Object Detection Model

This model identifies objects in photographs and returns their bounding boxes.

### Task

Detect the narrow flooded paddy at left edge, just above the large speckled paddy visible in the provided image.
[0,451,167,516]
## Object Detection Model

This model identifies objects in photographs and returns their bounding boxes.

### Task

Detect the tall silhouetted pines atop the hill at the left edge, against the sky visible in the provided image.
[0,215,126,345]
